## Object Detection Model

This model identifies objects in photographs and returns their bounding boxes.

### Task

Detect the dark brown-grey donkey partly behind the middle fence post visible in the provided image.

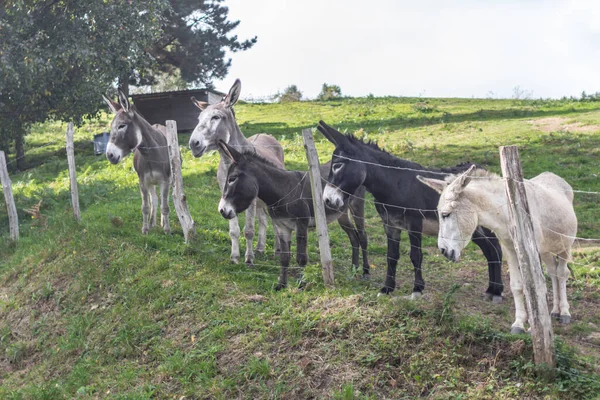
[213,142,369,290]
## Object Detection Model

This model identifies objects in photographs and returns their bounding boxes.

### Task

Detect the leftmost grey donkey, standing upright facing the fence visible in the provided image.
[102,89,171,234]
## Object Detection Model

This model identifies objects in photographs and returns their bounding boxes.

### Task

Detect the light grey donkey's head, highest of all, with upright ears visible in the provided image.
[189,79,242,157]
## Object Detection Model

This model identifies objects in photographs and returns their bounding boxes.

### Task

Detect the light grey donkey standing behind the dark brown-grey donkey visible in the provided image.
[189,79,285,265]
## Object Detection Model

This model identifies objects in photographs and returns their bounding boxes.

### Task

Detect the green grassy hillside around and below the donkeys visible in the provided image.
[0,98,600,399]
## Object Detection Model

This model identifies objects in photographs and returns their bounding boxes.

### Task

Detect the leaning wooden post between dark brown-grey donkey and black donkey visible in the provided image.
[302,129,334,286]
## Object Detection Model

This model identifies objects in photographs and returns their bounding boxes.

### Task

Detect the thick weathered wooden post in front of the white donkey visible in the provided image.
[500,146,556,374]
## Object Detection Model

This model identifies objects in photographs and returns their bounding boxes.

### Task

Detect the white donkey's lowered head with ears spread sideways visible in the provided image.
[417,165,478,261]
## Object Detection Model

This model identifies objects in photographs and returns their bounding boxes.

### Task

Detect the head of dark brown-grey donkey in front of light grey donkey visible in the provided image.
[218,141,258,219]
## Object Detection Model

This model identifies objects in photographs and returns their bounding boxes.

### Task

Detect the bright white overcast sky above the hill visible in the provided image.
[215,0,600,98]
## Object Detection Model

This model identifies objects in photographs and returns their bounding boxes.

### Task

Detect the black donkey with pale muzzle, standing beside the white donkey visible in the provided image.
[318,121,504,303]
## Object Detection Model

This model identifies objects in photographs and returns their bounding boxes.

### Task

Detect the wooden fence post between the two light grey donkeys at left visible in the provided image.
[167,120,196,243]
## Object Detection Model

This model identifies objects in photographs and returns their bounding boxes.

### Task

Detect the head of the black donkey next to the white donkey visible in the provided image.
[317,121,367,210]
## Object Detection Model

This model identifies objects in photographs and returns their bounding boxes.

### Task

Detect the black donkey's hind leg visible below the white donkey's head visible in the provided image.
[472,226,504,304]
